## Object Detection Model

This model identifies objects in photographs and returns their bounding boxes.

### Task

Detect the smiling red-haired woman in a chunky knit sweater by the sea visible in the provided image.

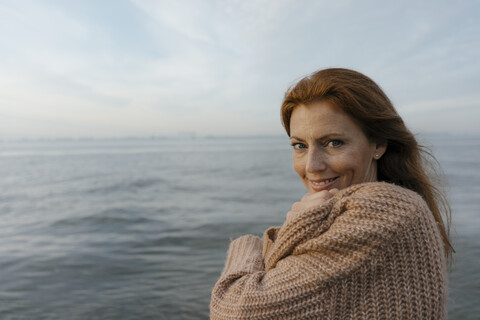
[210,69,452,319]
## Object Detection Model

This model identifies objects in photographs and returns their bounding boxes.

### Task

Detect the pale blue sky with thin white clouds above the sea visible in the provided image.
[0,0,480,140]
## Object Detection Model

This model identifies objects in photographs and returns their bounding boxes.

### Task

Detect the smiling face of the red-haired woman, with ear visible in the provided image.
[290,101,386,193]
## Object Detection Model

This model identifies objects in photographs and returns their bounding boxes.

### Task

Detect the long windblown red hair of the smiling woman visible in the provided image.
[281,68,453,258]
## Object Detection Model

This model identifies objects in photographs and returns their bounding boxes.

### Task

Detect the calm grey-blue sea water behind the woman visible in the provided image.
[0,136,480,319]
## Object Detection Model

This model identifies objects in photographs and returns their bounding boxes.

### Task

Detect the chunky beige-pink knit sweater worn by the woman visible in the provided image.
[210,182,447,320]
